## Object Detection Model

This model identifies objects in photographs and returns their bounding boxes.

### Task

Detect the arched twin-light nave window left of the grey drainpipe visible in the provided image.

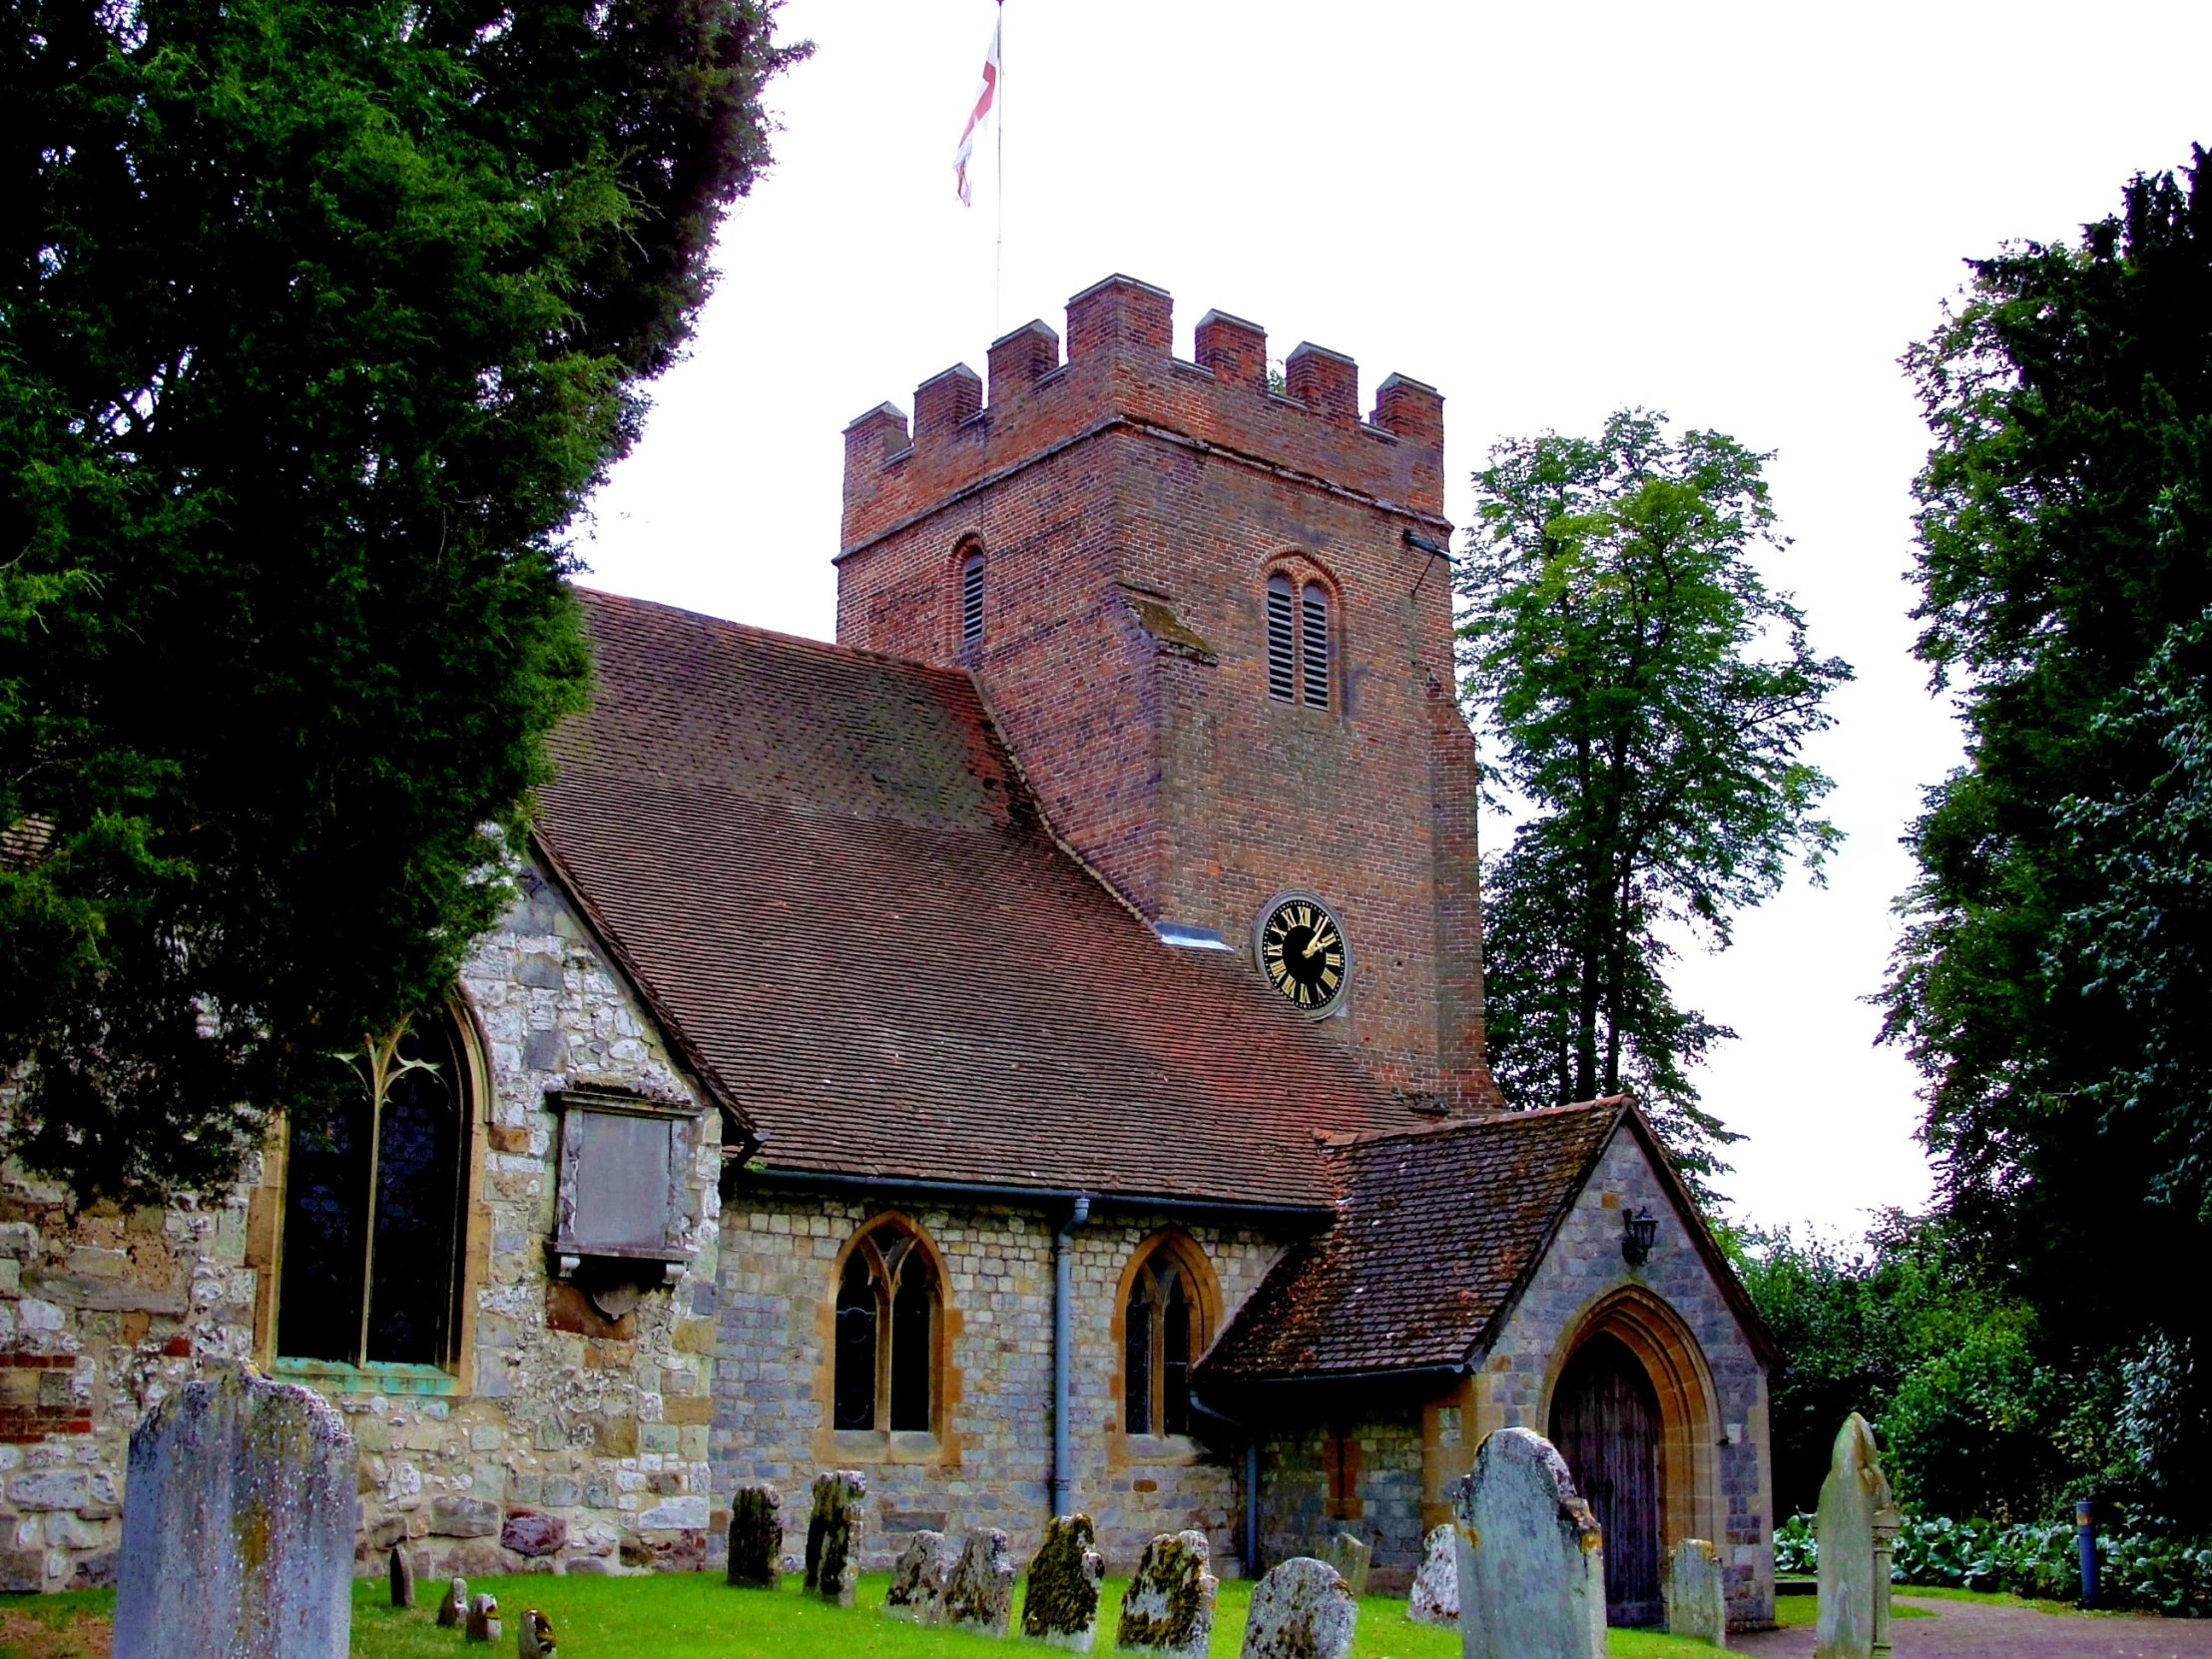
[831,1217,944,1433]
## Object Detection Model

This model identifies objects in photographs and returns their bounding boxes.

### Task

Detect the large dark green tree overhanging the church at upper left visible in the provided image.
[0,0,803,1201]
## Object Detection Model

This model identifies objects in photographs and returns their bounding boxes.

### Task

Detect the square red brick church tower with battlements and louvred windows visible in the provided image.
[838,276,1495,1106]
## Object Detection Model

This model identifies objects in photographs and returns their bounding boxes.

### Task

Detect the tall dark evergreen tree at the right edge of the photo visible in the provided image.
[1885,148,2212,1491]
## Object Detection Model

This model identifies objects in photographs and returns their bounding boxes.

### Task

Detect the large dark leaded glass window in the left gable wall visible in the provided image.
[276,1013,473,1372]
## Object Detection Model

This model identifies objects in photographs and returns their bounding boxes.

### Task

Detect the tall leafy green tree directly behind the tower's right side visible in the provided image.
[1457,409,1852,1177]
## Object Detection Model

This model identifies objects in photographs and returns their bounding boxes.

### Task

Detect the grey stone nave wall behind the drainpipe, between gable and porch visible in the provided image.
[713,1190,1279,1573]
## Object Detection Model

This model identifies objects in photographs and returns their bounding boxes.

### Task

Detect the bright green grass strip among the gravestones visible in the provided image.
[335,1573,1712,1659]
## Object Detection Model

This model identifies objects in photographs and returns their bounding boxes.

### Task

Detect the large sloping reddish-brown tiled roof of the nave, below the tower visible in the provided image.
[537,593,1413,1208]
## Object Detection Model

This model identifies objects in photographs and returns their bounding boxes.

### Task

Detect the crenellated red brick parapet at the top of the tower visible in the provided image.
[838,276,1444,553]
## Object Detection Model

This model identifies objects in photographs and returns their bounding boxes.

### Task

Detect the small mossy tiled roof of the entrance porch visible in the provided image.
[1199,1099,1628,1382]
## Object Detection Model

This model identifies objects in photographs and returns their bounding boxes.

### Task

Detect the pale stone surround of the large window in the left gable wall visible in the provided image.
[246,986,493,1400]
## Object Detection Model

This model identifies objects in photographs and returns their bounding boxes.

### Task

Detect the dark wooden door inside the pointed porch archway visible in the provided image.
[1550,1336,1661,1626]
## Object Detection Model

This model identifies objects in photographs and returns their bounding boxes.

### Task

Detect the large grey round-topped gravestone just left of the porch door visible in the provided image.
[1453,1429,1606,1659]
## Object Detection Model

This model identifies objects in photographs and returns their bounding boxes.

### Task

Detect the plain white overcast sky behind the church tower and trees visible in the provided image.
[582,0,2212,1232]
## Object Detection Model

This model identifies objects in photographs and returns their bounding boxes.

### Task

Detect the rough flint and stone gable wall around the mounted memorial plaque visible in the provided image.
[0,873,721,1590]
